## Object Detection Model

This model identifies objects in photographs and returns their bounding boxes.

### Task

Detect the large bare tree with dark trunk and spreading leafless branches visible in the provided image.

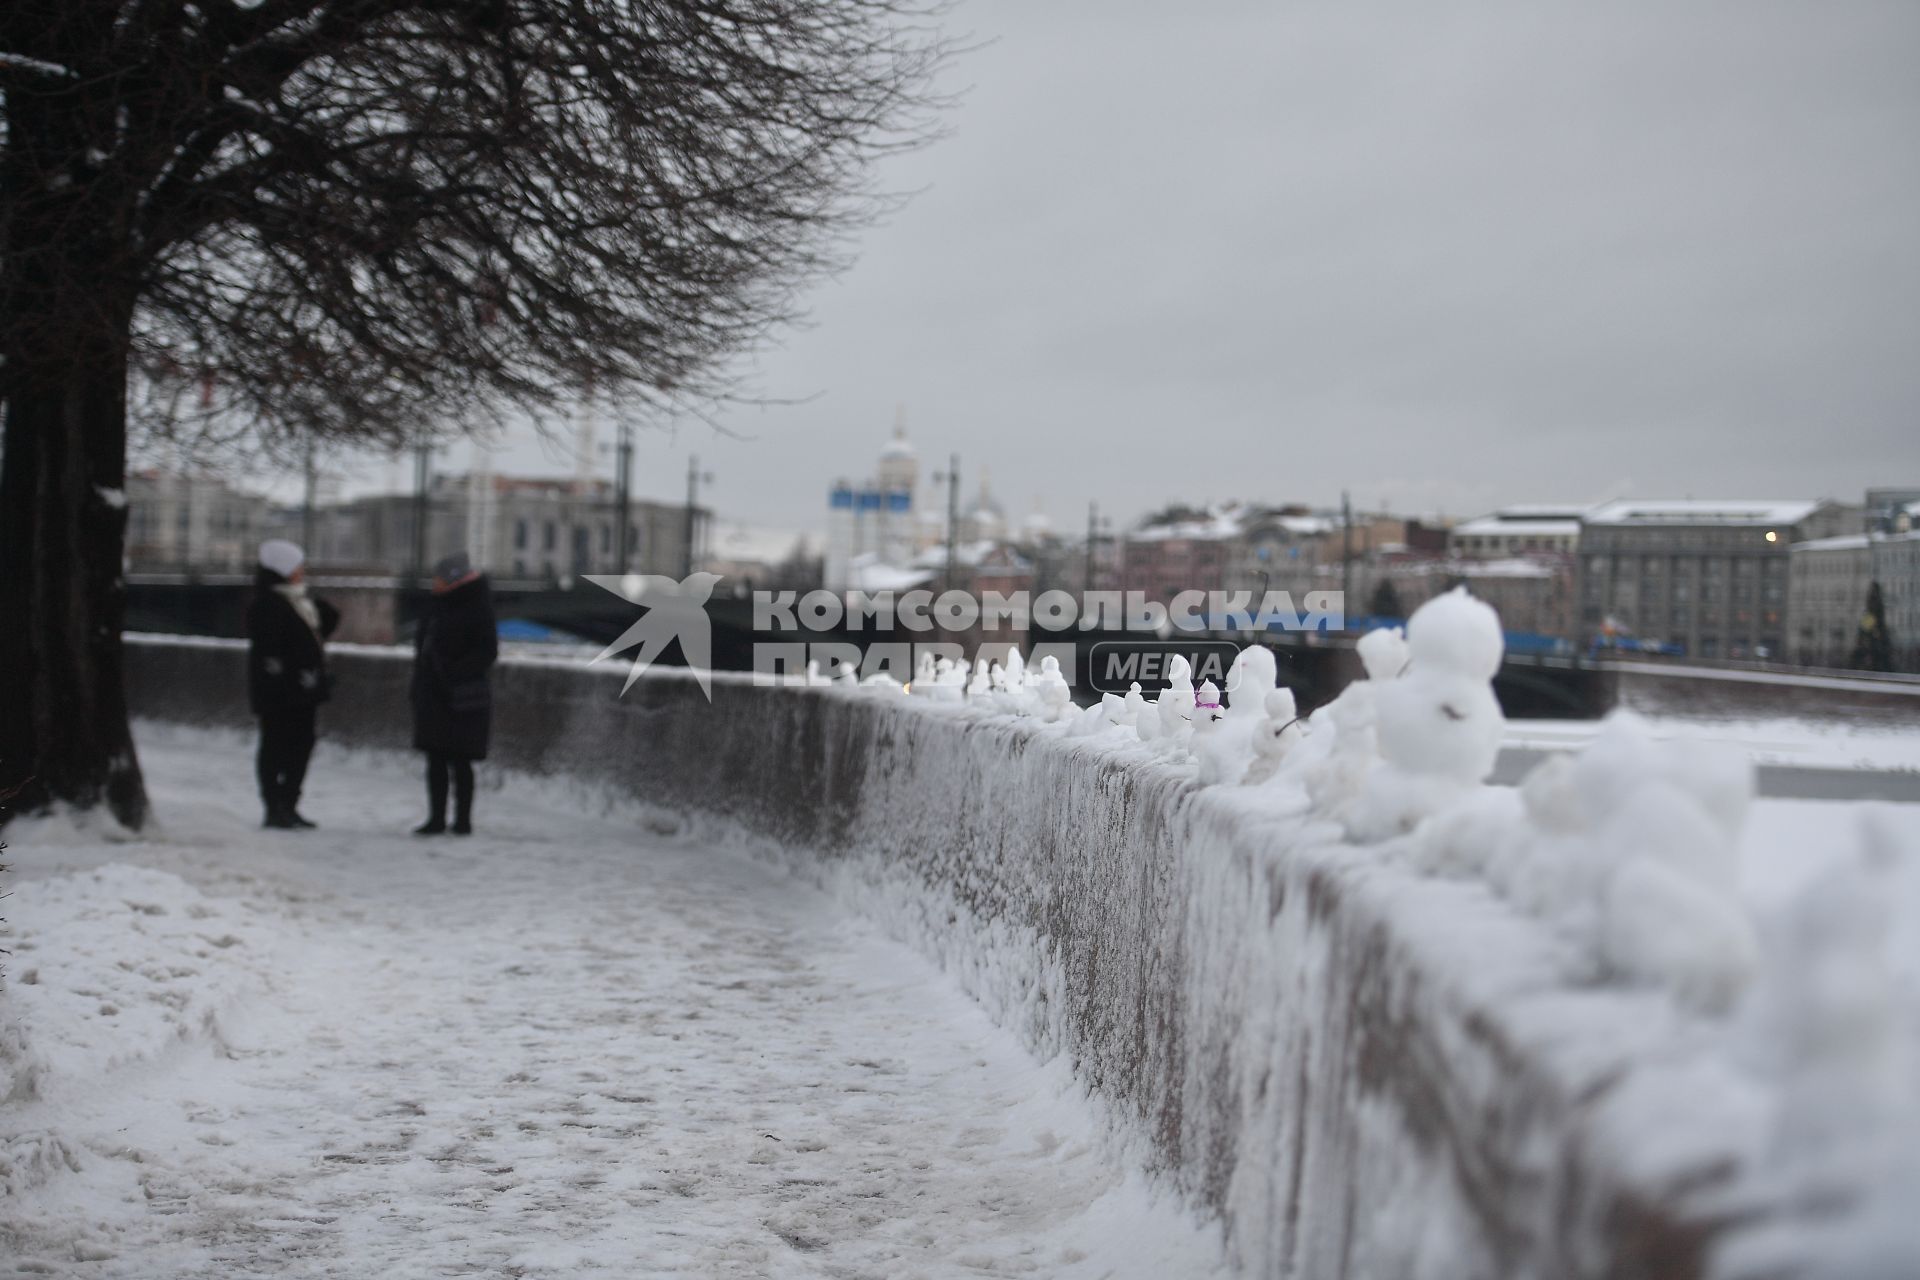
[0,0,947,825]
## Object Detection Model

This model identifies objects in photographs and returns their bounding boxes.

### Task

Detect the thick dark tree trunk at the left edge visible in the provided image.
[0,320,148,827]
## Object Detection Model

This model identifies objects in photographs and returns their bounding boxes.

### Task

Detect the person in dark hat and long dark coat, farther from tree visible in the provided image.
[413,551,499,835]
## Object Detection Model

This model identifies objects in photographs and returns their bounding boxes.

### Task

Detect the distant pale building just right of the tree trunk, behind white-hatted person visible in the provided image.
[127,470,275,572]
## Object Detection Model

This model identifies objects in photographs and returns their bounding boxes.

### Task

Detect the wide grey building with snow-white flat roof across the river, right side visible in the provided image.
[1576,499,1860,658]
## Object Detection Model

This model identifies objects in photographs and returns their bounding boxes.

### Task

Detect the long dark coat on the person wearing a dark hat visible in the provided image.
[413,578,499,760]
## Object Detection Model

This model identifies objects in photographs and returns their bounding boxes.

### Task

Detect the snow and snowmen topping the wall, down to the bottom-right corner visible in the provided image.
[894,591,1920,1276]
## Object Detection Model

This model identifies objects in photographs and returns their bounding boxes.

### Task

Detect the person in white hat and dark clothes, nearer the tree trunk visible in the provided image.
[246,539,340,831]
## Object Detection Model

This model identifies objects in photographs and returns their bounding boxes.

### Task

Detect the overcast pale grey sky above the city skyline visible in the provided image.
[345,0,1920,528]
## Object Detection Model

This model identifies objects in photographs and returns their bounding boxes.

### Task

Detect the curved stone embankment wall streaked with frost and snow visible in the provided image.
[127,637,1751,1276]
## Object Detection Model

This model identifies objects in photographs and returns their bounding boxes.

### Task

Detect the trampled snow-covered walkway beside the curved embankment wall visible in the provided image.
[0,731,1221,1278]
